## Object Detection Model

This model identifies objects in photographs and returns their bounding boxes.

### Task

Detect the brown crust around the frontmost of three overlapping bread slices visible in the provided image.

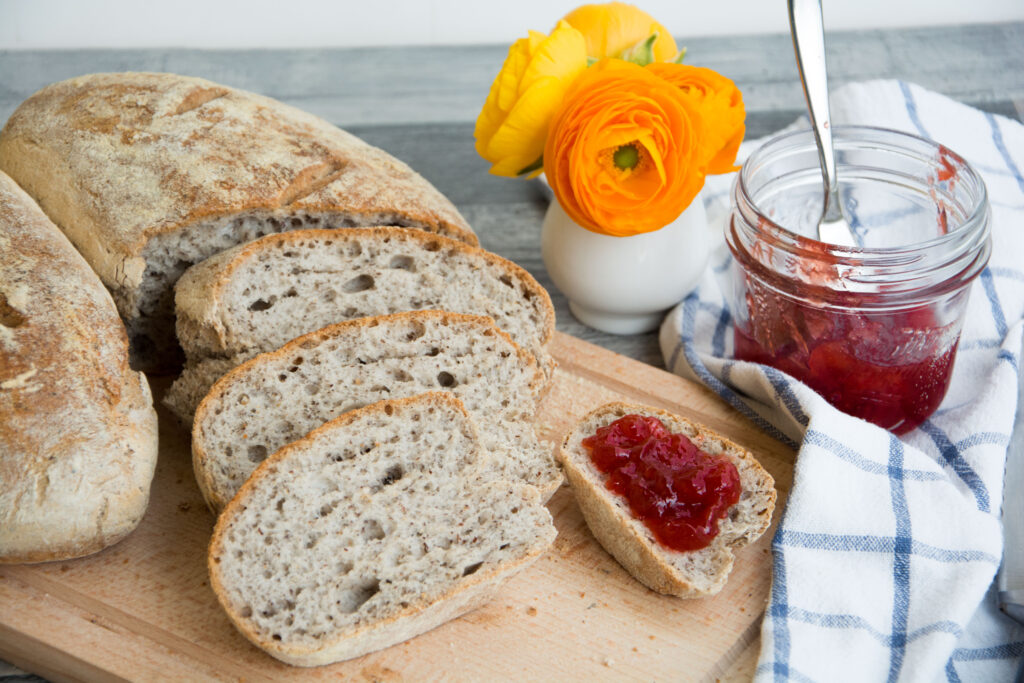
[207,392,555,667]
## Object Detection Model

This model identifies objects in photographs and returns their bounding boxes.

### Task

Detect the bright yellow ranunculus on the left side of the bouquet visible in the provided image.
[473,22,587,177]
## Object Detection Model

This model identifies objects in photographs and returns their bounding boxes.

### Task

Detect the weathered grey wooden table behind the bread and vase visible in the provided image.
[0,24,1024,681]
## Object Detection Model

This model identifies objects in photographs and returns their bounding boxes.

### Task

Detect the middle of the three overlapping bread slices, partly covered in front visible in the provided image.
[193,311,562,510]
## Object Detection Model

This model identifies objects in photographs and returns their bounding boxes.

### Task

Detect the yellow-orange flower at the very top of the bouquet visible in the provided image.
[562,2,679,61]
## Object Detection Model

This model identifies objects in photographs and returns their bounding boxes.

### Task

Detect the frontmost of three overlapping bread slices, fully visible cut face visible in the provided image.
[209,393,555,667]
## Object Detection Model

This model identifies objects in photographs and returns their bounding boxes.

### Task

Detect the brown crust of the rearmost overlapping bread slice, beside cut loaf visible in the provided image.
[174,226,555,356]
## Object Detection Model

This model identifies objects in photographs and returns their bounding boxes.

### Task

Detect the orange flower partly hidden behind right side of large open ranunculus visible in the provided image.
[647,63,746,173]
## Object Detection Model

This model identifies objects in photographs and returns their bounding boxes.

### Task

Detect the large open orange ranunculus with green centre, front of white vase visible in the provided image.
[544,59,705,237]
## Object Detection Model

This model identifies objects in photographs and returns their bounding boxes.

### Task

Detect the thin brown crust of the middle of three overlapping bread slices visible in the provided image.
[191,310,548,512]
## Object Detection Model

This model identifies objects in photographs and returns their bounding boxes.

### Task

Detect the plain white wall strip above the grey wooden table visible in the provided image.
[0,0,1024,49]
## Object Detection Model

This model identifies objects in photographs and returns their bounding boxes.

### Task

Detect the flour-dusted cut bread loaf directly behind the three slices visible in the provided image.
[0,73,476,371]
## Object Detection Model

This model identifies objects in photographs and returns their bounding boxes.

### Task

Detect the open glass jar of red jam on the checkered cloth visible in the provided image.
[726,126,991,434]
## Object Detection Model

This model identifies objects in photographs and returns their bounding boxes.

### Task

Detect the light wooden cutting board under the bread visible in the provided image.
[0,334,794,681]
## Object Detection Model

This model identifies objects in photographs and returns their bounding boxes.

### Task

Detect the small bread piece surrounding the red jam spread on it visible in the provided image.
[559,403,776,598]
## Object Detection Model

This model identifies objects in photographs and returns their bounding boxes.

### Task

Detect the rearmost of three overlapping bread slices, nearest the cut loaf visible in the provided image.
[165,227,555,424]
